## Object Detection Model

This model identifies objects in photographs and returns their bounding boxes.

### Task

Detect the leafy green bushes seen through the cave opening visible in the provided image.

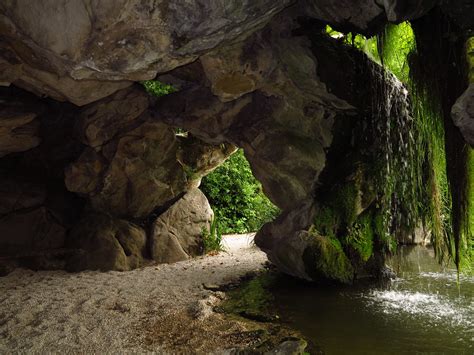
[200,149,280,233]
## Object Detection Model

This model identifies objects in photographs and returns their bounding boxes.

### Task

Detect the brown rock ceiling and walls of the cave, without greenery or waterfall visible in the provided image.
[0,0,472,282]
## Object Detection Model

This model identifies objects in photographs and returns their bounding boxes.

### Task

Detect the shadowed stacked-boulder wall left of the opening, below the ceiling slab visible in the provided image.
[0,86,230,273]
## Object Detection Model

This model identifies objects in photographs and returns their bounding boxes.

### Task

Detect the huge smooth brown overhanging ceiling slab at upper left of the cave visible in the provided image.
[0,0,293,105]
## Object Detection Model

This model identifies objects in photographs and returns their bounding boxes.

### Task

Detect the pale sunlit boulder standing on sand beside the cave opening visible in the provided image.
[151,189,213,263]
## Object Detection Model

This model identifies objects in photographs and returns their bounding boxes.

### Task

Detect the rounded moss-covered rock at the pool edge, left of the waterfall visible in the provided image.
[303,235,354,284]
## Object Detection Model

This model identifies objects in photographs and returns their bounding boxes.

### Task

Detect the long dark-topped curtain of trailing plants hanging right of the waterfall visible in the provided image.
[409,9,473,271]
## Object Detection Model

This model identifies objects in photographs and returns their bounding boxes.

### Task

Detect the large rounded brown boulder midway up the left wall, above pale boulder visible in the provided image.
[66,122,186,218]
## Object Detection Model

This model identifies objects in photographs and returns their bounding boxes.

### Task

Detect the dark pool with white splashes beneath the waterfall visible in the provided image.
[275,247,474,354]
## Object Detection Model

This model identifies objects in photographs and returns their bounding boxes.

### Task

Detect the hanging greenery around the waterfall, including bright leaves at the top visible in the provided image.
[322,20,474,272]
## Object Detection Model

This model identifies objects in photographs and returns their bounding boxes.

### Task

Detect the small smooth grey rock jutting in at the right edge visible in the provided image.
[451,84,474,148]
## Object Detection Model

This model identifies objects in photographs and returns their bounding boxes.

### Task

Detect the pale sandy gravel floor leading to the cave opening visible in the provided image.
[0,235,266,354]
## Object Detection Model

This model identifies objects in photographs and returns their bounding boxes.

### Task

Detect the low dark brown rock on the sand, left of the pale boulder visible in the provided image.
[67,213,146,271]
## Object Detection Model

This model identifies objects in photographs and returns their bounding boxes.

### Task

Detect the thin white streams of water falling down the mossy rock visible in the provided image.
[367,59,417,246]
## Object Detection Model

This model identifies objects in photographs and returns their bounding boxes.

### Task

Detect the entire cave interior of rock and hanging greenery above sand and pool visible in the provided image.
[0,0,474,350]
